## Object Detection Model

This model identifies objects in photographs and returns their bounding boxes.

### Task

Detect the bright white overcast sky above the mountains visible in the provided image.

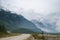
[0,0,60,19]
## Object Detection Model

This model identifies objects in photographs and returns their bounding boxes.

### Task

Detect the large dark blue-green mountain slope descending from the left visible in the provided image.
[0,9,42,33]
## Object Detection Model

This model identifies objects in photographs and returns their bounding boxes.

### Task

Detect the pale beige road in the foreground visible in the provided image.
[0,34,31,40]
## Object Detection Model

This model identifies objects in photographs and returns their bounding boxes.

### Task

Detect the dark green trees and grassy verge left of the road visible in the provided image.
[0,24,20,38]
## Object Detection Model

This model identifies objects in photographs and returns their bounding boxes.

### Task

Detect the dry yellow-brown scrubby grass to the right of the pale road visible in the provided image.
[32,34,60,40]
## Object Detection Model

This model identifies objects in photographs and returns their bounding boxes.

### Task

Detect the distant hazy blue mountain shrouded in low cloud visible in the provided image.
[33,13,60,33]
